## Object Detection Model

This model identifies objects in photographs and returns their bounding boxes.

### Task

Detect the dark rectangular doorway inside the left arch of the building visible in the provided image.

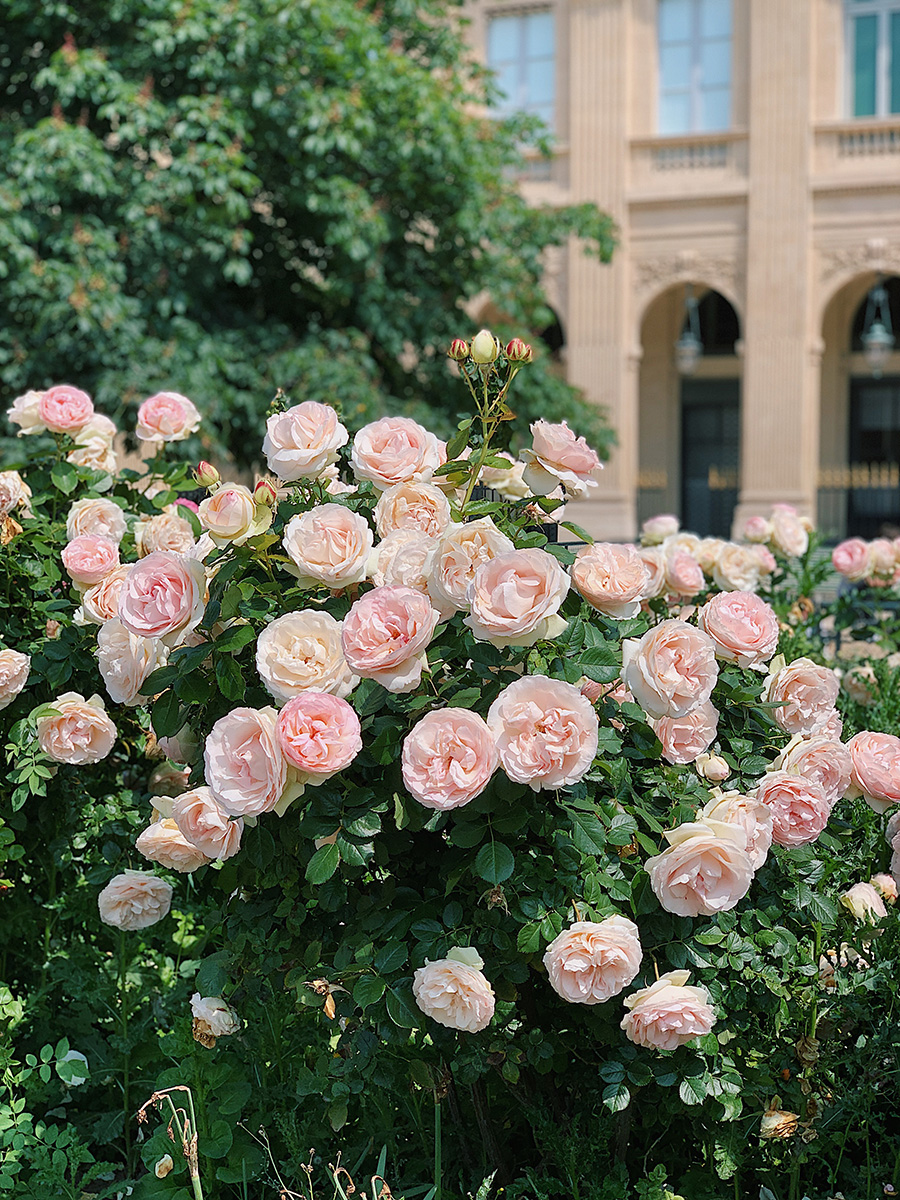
[682,379,740,538]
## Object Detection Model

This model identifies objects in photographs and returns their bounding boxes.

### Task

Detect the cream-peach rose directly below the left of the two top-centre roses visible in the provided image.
[282,504,374,592]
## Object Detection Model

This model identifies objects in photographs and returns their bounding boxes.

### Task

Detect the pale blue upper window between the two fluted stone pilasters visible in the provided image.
[659,0,731,134]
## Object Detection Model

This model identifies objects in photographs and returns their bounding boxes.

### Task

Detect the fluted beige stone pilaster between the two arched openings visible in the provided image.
[734,0,818,528]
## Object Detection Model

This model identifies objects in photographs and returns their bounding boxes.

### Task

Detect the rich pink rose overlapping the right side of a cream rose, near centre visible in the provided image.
[341,587,438,692]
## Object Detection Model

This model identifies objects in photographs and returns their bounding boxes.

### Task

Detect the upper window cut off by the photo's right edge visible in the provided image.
[845,0,900,116]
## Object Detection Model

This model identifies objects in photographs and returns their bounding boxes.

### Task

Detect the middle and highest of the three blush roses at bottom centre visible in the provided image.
[544,916,643,1004]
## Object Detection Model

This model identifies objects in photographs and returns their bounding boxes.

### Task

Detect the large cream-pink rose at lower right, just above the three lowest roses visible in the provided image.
[644,818,754,917]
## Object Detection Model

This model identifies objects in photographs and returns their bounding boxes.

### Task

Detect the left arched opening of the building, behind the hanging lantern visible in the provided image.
[638,284,740,536]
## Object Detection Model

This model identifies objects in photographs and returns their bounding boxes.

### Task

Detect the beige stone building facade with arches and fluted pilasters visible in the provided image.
[469,0,900,539]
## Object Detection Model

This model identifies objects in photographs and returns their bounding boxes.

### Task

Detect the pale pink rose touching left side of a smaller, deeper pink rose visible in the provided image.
[203,708,296,817]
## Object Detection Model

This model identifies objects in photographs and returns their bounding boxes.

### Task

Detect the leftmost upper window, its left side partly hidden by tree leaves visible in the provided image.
[487,10,556,127]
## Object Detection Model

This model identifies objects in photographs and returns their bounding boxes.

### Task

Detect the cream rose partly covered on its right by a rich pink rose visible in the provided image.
[257,608,360,703]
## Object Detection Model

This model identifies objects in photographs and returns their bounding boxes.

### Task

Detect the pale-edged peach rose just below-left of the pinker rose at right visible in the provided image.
[622,620,719,718]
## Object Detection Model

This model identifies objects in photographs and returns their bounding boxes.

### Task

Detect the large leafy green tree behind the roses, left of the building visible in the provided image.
[0,0,613,456]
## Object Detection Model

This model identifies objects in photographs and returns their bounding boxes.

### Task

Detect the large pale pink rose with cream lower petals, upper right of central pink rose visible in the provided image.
[463,550,569,646]
